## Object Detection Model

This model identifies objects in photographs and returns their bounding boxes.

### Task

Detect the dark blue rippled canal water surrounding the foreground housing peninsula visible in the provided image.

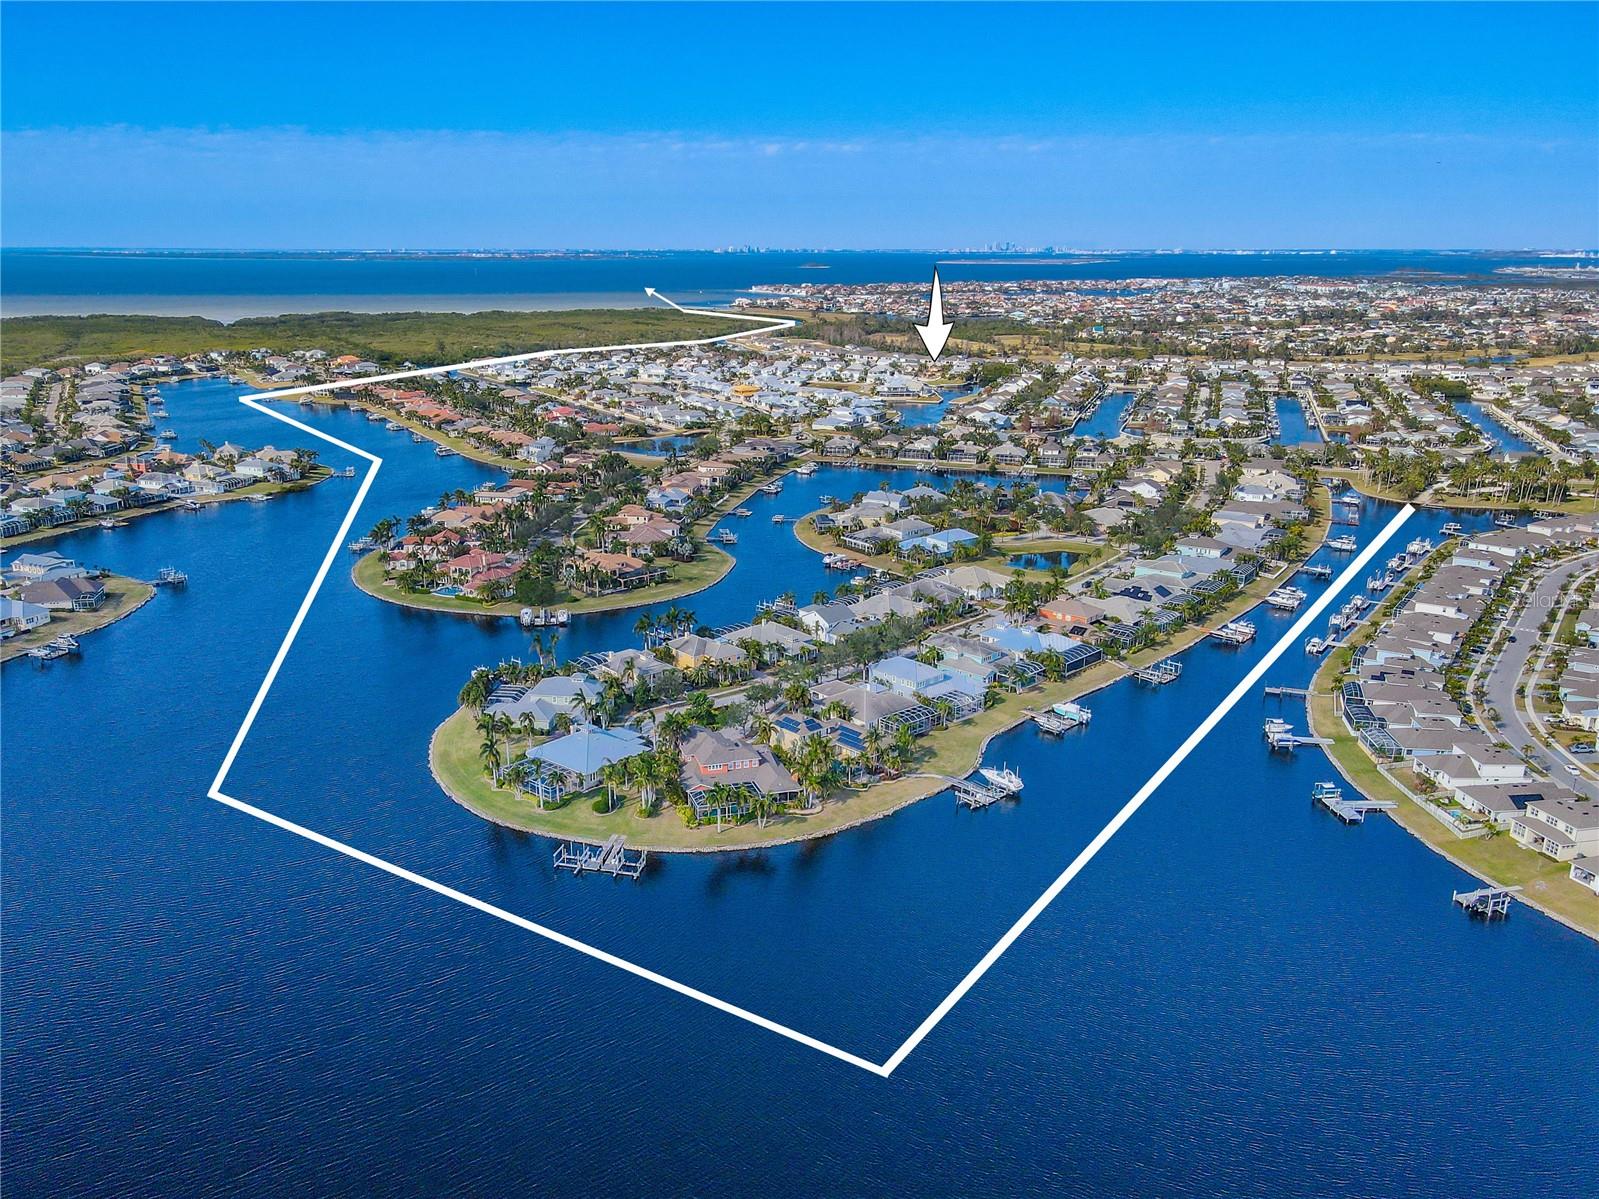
[3,384,1599,1196]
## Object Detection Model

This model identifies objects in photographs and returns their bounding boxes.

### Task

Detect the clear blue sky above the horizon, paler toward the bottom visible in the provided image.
[0,3,1599,248]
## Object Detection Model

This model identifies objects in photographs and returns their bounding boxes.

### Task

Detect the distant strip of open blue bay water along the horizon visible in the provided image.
[0,248,1573,315]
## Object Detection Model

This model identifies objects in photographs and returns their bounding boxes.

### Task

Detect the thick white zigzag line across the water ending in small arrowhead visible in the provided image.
[206,288,1415,1078]
